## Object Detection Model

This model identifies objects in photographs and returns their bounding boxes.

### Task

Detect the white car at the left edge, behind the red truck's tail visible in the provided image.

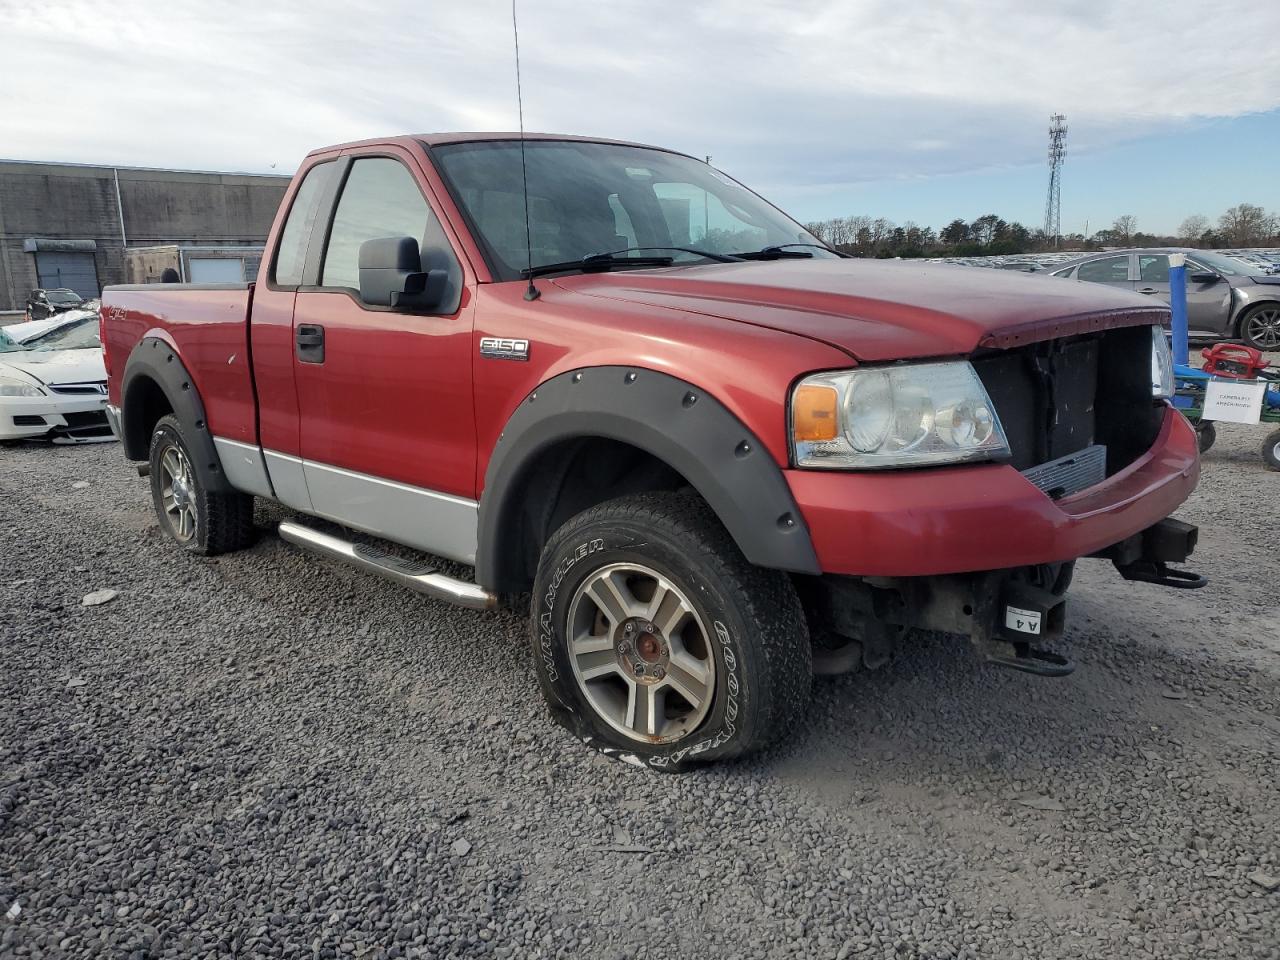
[0,311,115,443]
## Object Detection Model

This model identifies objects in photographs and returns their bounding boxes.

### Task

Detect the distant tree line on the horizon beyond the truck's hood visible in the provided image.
[805,204,1280,257]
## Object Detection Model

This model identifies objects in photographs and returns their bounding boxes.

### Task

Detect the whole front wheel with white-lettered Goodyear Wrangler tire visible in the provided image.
[532,494,812,771]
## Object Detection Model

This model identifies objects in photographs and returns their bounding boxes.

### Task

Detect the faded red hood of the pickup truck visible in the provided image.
[556,260,1169,362]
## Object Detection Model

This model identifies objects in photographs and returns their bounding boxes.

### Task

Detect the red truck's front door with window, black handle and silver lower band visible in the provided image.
[293,147,476,563]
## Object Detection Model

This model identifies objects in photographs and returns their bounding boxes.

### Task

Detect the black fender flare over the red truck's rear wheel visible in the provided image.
[120,337,232,493]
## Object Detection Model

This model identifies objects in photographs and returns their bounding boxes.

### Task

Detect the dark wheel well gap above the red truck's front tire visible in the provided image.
[498,436,690,593]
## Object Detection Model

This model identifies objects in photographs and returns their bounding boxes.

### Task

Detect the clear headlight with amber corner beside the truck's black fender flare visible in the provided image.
[791,360,1009,470]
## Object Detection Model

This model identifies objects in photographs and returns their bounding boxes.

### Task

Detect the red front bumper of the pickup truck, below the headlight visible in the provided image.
[786,407,1199,577]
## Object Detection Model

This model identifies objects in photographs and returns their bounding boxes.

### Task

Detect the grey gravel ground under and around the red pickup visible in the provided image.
[0,426,1280,960]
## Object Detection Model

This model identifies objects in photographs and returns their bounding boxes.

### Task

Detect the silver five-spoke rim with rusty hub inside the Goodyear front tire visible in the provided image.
[566,563,716,744]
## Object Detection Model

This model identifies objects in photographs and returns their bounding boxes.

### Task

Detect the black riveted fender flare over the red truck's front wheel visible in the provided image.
[476,366,822,591]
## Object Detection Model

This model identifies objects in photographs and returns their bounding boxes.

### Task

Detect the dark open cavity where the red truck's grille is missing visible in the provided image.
[973,326,1164,481]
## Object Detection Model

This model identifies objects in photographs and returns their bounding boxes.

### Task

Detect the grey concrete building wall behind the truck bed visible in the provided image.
[0,160,289,311]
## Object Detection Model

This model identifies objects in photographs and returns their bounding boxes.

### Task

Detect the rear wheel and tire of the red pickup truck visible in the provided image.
[151,415,256,556]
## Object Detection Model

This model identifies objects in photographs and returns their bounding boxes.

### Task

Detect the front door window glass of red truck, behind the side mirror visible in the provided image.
[320,156,462,314]
